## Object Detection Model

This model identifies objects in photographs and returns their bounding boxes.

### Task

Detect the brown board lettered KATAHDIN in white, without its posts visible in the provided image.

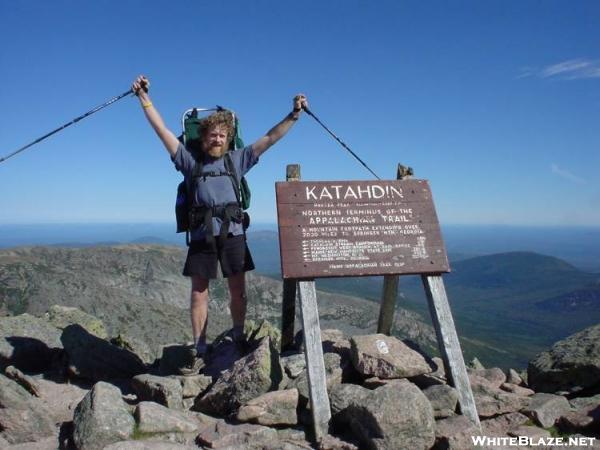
[275,179,450,279]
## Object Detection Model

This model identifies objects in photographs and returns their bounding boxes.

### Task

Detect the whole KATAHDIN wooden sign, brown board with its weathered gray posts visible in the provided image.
[276,166,479,439]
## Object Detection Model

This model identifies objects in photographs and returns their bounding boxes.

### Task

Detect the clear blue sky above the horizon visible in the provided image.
[0,0,600,226]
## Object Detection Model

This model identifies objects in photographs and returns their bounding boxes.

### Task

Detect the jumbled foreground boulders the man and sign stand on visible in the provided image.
[0,308,600,450]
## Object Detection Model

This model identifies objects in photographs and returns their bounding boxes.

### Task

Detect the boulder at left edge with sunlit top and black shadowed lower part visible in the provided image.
[0,314,62,372]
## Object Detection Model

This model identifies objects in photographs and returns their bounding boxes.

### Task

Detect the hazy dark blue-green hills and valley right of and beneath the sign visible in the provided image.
[319,252,600,367]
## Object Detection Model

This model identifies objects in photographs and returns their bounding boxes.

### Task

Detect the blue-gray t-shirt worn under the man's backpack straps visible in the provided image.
[173,144,258,241]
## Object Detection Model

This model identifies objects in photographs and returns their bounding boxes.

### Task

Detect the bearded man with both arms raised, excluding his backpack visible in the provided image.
[132,75,308,374]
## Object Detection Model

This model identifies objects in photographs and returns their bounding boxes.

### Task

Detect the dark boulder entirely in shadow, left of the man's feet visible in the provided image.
[61,325,146,381]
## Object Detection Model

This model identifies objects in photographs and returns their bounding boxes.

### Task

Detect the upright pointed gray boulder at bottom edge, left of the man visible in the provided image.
[73,382,135,450]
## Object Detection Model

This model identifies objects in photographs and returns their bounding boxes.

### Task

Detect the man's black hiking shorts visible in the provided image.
[183,234,254,280]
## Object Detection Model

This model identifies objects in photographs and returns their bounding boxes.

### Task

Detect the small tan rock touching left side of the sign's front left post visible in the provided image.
[237,389,298,426]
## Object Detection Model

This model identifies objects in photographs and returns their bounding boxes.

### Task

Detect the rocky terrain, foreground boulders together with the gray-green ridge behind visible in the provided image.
[0,246,600,450]
